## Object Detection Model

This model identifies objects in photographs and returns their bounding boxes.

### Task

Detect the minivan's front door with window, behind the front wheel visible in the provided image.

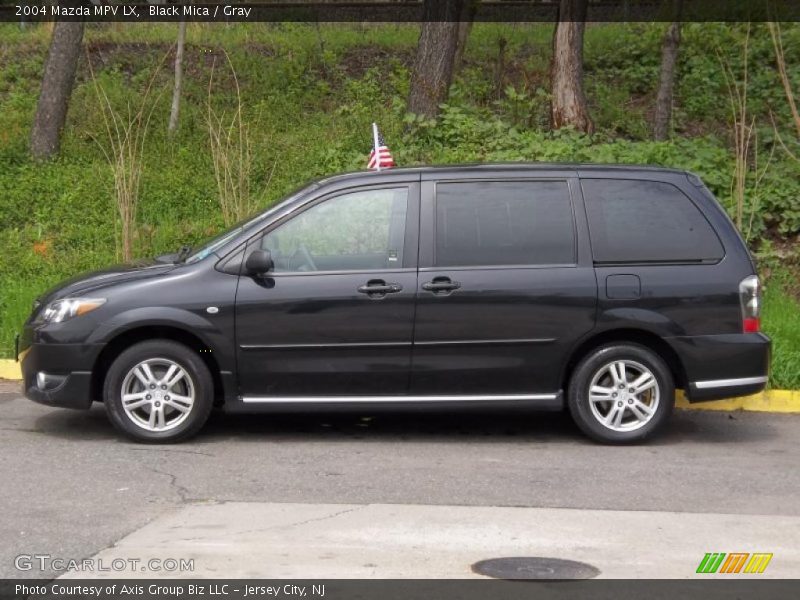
[236,182,419,401]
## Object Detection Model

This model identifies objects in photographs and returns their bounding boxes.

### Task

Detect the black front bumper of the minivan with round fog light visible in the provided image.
[20,342,103,409]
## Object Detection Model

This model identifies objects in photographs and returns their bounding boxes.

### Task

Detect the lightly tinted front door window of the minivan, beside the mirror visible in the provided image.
[261,187,408,273]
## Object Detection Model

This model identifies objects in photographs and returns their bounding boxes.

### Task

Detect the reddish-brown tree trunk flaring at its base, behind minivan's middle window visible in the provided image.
[550,0,594,133]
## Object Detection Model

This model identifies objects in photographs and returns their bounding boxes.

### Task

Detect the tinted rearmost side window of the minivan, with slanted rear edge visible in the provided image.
[581,179,725,263]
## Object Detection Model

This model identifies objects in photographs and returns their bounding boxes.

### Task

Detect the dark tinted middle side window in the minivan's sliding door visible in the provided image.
[435,181,575,267]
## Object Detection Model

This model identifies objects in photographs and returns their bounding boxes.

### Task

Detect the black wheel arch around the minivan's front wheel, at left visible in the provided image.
[91,325,225,404]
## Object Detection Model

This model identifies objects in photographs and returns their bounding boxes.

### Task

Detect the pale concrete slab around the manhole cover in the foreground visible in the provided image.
[59,502,800,579]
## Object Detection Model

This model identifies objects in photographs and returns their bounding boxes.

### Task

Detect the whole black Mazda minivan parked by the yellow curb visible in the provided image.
[19,164,770,443]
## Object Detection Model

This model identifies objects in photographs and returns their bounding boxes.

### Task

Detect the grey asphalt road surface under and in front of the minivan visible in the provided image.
[0,383,800,577]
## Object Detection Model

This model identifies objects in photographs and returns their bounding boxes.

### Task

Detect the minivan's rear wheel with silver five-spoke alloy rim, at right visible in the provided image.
[567,343,675,444]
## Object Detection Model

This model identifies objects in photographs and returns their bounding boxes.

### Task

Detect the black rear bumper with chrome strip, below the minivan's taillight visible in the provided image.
[666,333,772,402]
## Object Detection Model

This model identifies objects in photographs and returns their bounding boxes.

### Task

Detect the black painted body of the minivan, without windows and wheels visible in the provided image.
[20,165,770,411]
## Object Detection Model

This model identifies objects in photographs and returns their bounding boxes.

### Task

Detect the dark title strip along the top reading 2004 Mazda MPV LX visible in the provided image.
[0,0,800,23]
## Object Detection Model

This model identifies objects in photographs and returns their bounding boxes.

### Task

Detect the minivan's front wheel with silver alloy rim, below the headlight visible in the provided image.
[103,340,214,444]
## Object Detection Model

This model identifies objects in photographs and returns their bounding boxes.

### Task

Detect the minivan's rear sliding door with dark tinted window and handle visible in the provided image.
[411,178,597,400]
